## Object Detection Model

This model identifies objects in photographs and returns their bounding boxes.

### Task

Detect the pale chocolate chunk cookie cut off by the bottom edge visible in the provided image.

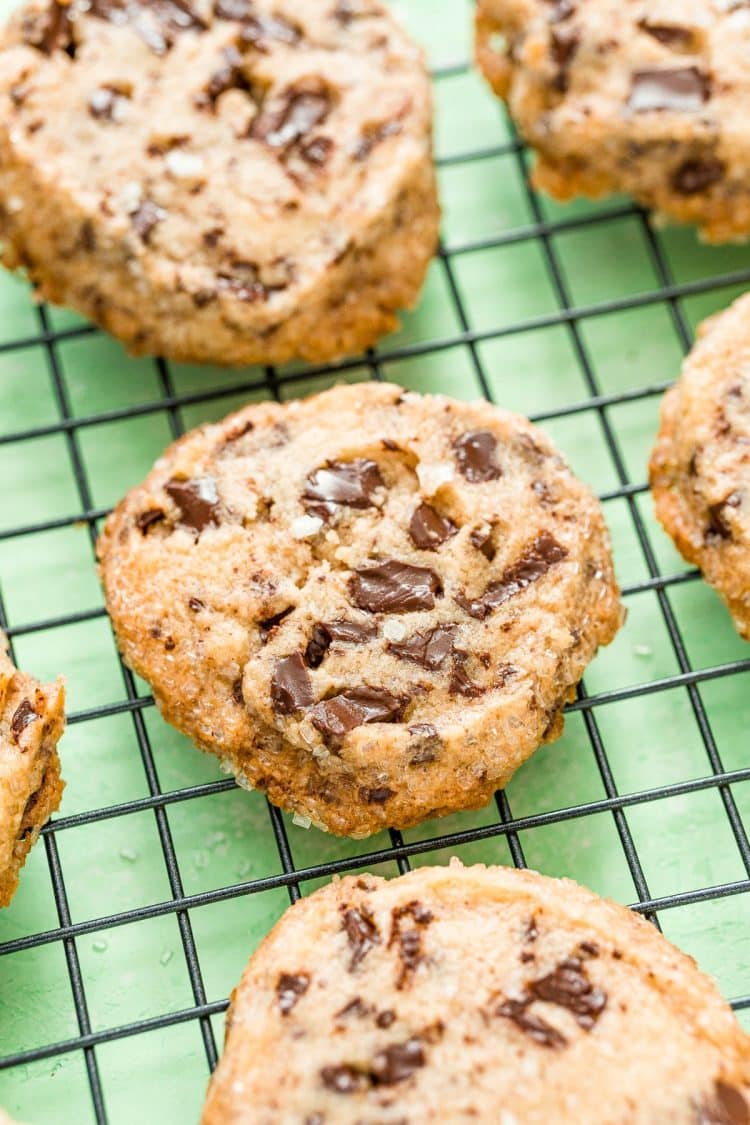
[201,861,750,1125]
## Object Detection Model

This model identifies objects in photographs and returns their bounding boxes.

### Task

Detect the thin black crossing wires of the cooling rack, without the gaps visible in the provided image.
[0,37,750,1125]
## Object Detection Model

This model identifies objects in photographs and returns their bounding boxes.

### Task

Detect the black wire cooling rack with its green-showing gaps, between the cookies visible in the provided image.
[0,0,750,1125]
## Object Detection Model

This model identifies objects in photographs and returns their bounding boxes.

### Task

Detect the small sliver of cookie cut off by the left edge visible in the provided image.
[0,635,65,907]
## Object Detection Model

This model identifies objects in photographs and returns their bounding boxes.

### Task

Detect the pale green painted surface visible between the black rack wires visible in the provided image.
[0,0,750,1125]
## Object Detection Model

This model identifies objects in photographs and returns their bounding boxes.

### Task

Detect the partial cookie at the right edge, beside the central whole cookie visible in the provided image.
[651,295,750,640]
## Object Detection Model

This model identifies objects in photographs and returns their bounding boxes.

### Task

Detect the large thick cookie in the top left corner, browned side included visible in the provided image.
[0,0,439,365]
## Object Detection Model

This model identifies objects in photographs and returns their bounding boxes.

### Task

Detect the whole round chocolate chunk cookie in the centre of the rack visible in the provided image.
[99,383,621,836]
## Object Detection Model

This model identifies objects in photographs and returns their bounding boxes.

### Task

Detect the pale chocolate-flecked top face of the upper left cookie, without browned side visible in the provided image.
[0,0,432,321]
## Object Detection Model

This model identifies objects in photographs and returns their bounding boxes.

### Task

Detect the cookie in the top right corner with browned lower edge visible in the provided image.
[477,0,750,242]
